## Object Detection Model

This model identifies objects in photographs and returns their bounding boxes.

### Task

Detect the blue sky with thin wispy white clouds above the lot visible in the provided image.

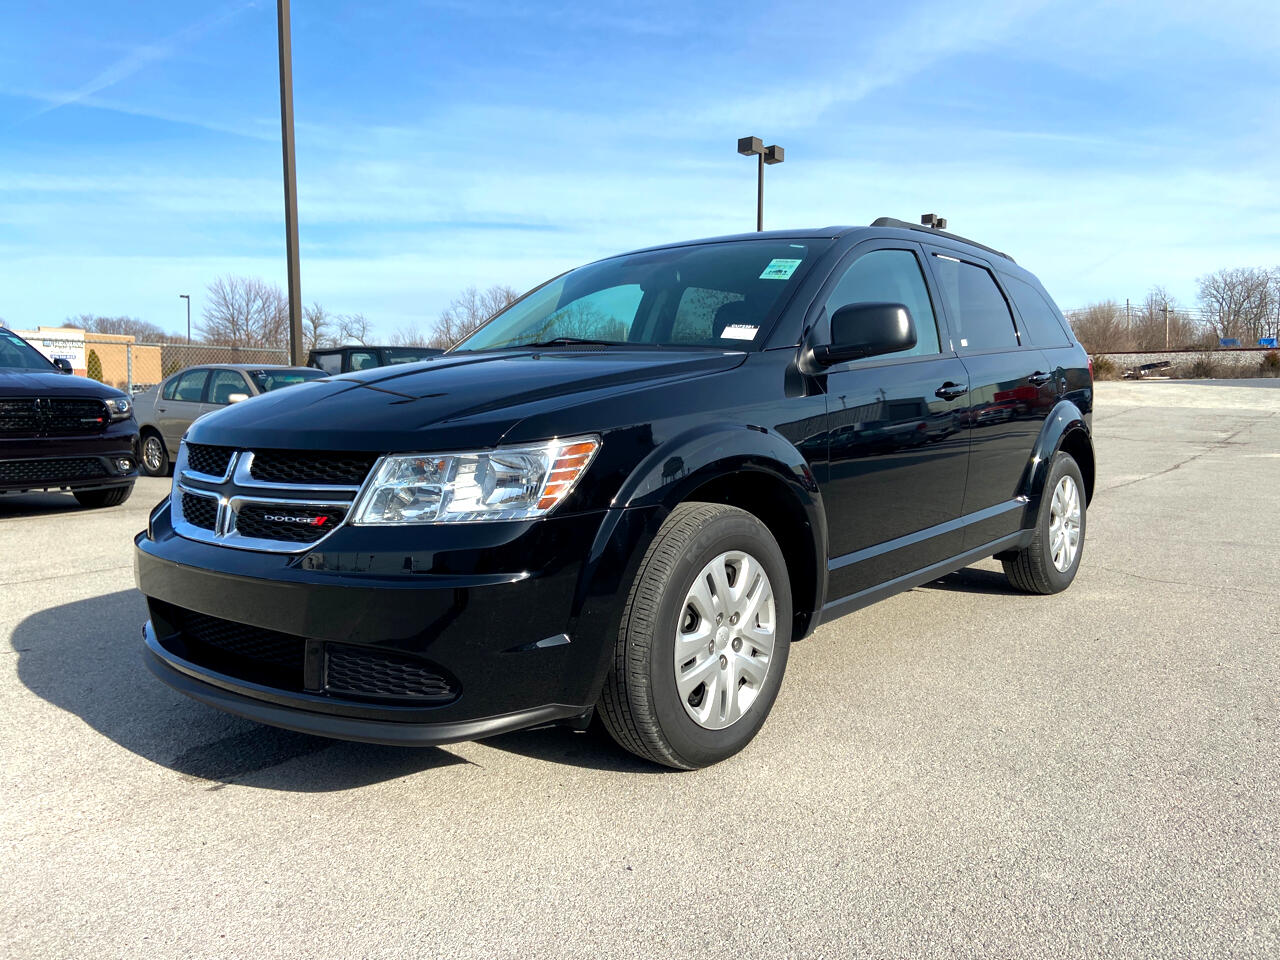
[0,0,1280,333]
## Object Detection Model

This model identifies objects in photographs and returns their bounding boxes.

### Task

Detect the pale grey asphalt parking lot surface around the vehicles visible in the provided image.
[0,383,1280,957]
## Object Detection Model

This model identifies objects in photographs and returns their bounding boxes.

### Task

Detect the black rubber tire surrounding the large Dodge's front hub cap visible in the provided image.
[599,503,791,769]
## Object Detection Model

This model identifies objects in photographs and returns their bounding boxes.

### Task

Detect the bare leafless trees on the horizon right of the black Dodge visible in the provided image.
[1068,266,1280,353]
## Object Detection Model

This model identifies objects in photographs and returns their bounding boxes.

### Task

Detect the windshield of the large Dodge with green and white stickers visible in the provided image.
[453,239,829,351]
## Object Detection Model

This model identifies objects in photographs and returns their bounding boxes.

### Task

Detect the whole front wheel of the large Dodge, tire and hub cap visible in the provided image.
[600,503,791,769]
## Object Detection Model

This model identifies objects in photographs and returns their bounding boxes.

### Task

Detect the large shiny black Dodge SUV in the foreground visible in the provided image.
[136,220,1094,768]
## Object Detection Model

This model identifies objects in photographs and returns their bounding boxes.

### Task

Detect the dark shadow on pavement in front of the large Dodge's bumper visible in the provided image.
[13,591,466,792]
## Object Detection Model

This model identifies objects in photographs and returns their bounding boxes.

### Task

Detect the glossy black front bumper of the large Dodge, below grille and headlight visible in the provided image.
[134,504,634,745]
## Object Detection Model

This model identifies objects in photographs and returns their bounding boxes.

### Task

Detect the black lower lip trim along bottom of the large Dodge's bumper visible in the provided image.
[142,634,589,746]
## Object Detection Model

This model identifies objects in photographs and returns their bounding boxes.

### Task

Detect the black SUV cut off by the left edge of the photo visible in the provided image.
[0,328,138,507]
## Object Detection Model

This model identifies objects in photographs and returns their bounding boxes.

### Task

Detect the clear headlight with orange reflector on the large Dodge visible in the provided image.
[352,436,600,524]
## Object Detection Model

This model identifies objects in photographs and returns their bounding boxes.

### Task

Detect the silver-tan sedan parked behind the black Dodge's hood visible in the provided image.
[133,364,329,476]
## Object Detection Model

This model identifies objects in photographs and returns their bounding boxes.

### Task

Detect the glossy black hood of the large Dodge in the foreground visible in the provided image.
[189,348,746,452]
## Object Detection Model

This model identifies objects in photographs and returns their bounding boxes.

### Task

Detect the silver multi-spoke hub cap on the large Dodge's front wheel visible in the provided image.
[675,550,777,730]
